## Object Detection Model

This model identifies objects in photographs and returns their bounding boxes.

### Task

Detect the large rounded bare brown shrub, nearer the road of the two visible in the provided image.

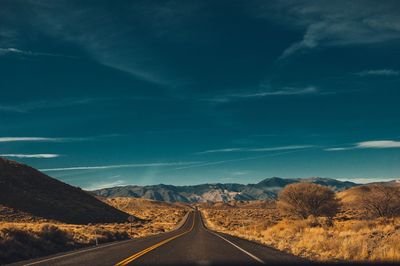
[278,183,340,219]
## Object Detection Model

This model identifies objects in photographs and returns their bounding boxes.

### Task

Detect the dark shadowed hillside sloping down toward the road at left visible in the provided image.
[0,158,129,224]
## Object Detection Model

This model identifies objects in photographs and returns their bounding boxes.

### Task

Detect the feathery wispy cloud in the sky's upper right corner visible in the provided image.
[260,1,400,60]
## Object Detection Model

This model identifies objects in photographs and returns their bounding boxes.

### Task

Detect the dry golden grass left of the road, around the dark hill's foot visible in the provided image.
[0,198,187,265]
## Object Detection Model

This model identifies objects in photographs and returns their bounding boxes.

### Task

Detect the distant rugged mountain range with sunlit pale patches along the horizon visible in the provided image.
[91,177,358,203]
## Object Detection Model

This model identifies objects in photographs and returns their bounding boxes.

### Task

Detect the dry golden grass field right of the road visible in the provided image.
[201,200,400,261]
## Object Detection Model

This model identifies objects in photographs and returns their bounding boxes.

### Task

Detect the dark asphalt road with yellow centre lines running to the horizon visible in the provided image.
[13,211,303,266]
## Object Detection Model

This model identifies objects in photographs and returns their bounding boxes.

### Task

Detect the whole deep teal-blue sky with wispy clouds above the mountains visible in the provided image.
[0,0,400,189]
